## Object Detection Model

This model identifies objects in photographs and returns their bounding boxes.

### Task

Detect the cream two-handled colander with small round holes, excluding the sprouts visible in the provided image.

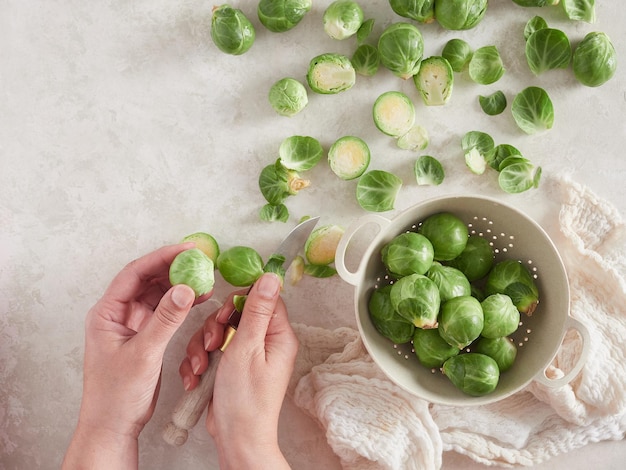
[335,196,590,405]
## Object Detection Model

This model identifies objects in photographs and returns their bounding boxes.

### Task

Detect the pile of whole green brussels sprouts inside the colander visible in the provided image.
[368,212,539,396]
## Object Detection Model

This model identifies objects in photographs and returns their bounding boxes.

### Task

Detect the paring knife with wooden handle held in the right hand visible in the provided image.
[163,217,319,446]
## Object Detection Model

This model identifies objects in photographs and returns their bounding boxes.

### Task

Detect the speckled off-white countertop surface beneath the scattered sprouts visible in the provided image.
[0,0,626,469]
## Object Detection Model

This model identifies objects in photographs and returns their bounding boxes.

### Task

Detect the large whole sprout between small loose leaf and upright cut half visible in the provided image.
[378,23,424,80]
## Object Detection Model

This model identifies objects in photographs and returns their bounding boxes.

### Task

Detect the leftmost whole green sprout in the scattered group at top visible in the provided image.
[211,5,256,55]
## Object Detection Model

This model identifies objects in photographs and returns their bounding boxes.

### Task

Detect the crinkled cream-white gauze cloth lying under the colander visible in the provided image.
[289,179,626,470]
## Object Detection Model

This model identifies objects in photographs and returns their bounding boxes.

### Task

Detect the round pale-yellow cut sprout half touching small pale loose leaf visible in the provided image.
[373,91,415,137]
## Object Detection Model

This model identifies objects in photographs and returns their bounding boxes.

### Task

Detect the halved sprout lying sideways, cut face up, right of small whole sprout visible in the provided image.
[306,52,356,95]
